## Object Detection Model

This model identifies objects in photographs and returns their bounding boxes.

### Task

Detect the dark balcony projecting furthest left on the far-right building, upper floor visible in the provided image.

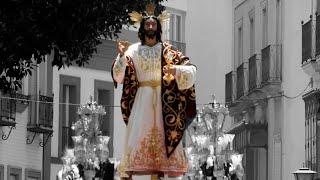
[302,20,312,64]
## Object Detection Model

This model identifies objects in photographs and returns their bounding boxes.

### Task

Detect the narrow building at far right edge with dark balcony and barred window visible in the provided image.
[301,0,320,177]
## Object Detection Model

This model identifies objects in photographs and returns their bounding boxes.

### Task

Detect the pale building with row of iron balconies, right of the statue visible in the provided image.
[225,0,313,180]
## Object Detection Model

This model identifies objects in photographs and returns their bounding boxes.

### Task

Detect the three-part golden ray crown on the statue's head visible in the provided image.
[129,3,170,23]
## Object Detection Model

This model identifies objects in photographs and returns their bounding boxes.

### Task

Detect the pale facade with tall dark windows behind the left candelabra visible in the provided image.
[50,37,126,180]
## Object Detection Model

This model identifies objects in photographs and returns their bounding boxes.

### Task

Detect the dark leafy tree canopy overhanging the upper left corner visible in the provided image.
[0,0,163,91]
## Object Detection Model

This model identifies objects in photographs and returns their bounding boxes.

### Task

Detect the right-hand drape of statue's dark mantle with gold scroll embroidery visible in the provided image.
[161,43,196,157]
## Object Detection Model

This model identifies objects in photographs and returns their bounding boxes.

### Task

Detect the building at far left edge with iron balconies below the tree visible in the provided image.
[0,56,53,180]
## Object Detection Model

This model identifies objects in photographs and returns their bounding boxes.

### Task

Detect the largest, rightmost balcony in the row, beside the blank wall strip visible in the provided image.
[261,45,282,86]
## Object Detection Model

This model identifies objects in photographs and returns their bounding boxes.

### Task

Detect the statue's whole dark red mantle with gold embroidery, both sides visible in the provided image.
[111,43,197,157]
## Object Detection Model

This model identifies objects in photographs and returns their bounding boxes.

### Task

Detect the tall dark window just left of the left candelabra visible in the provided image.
[58,75,80,156]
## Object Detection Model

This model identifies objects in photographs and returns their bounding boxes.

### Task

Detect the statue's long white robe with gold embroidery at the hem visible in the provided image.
[113,43,196,176]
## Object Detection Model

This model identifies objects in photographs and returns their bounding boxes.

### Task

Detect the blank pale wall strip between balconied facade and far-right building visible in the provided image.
[282,0,311,180]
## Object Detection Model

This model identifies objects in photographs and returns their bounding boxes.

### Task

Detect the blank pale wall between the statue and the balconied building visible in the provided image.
[185,0,232,106]
